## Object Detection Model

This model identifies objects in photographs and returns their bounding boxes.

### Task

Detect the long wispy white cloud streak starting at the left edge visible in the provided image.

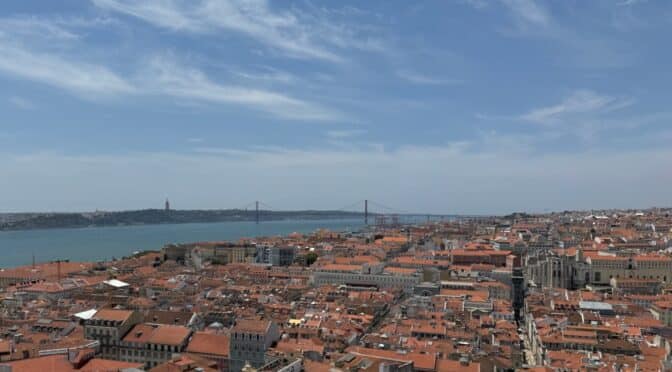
[0,18,340,121]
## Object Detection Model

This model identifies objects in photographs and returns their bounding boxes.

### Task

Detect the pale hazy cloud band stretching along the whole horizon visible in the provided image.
[5,143,672,214]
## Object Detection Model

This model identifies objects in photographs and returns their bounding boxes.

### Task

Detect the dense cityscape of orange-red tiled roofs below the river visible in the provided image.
[0,209,672,372]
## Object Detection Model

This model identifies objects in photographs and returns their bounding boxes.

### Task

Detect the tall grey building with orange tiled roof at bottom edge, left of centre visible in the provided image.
[229,319,280,372]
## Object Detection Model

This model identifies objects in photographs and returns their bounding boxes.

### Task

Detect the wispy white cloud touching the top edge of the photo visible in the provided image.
[93,0,381,62]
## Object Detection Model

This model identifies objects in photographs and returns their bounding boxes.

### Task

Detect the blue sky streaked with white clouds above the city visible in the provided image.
[0,0,672,214]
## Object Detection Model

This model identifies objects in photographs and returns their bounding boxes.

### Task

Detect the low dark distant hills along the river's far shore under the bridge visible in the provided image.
[0,209,364,230]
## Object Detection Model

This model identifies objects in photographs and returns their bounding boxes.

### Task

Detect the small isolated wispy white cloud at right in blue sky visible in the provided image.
[520,90,634,124]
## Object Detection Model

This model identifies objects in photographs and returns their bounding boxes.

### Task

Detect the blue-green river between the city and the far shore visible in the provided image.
[0,219,363,268]
